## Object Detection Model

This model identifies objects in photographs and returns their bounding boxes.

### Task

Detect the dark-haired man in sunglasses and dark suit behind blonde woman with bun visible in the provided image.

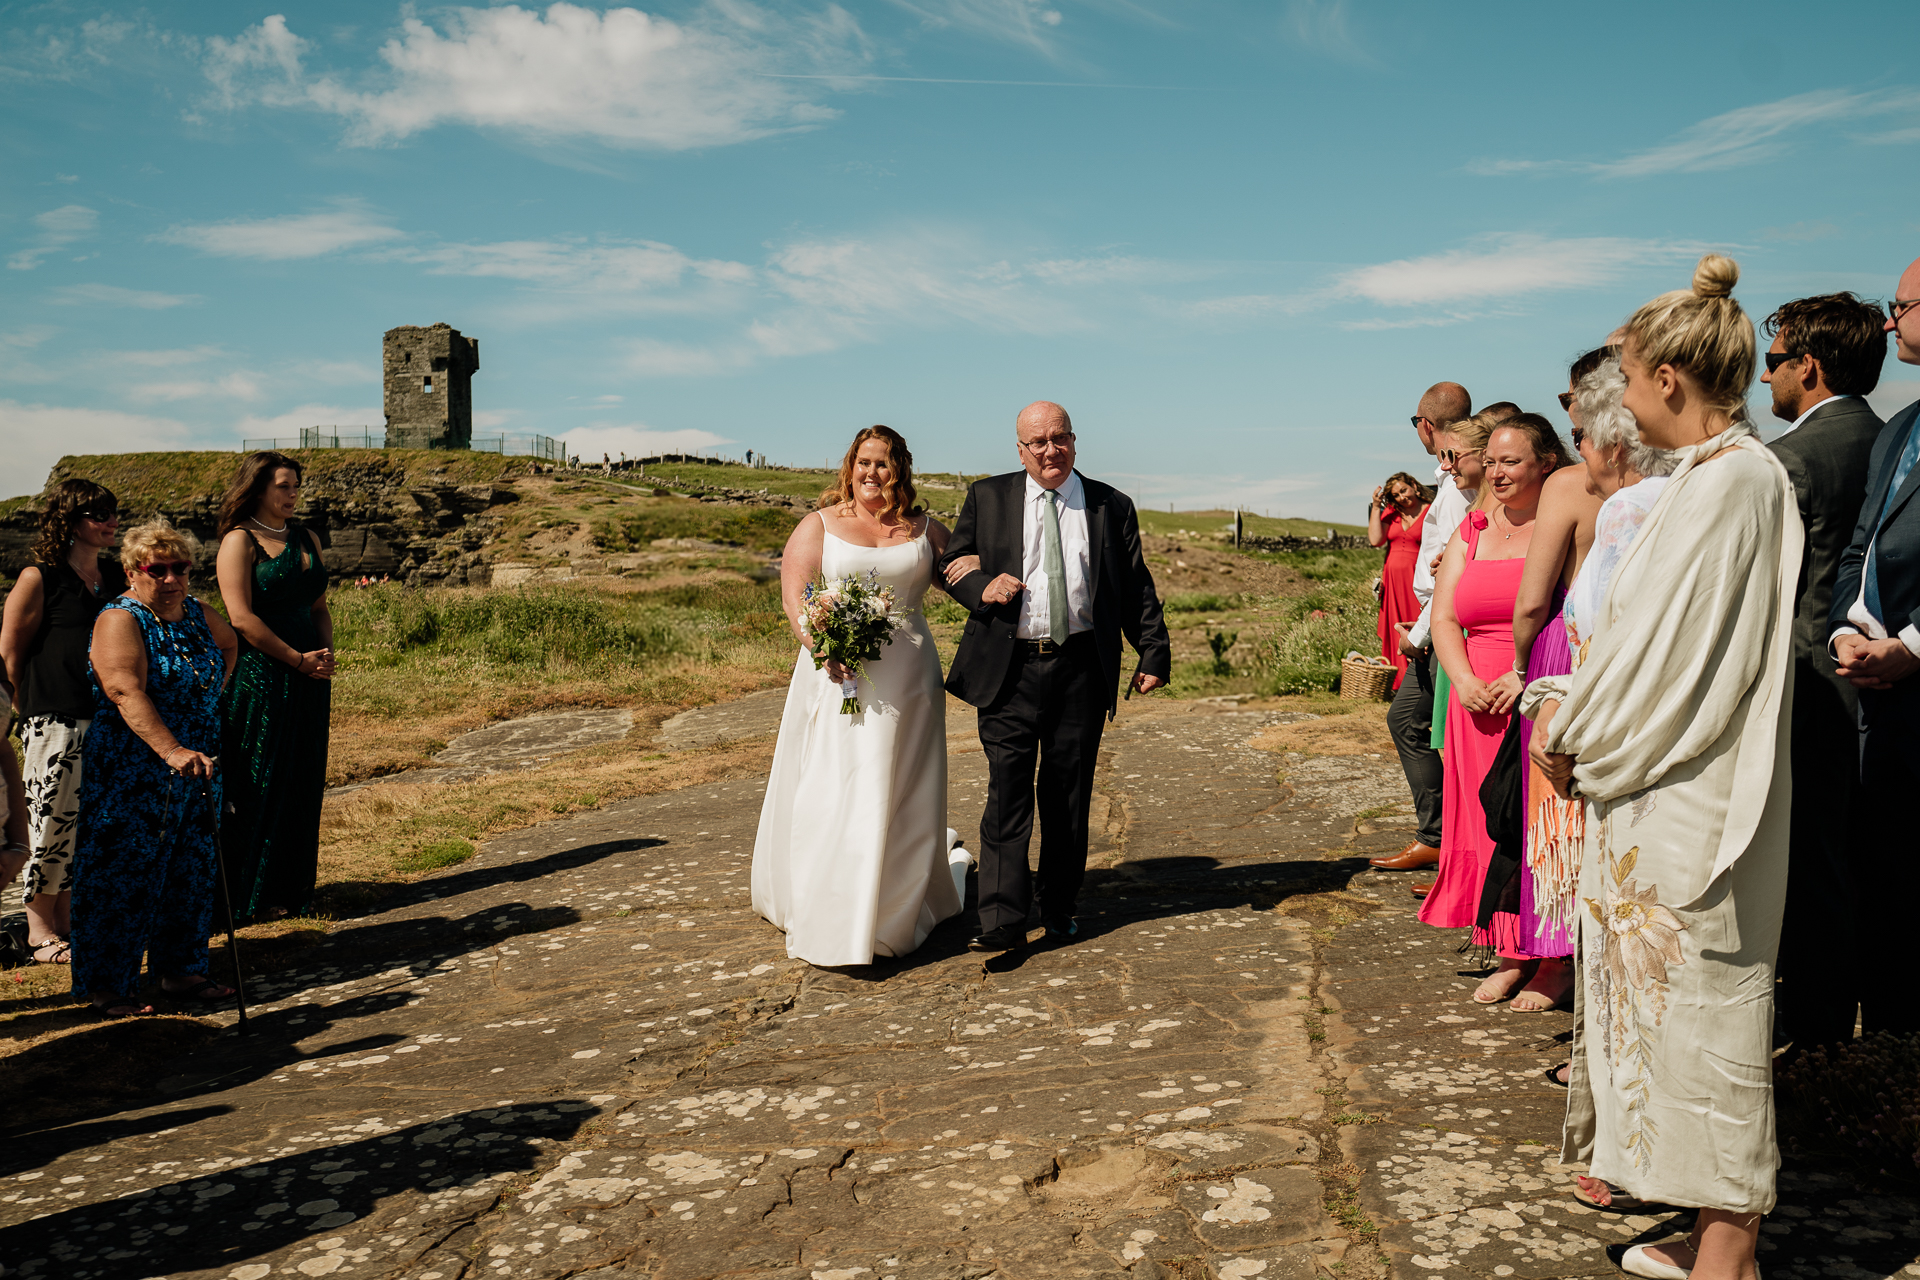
[1761,294,1887,1048]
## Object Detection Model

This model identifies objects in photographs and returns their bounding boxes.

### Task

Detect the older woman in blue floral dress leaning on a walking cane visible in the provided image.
[73,520,236,1017]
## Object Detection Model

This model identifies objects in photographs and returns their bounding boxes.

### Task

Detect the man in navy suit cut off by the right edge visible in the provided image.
[1827,261,1920,1032]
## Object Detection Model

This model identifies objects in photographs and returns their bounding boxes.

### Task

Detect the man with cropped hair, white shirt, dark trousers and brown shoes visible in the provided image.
[1373,382,1473,871]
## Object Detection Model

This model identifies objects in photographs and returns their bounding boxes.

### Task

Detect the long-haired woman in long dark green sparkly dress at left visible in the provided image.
[219,453,334,921]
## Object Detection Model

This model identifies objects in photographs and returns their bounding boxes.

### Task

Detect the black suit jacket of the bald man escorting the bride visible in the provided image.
[941,470,1173,716]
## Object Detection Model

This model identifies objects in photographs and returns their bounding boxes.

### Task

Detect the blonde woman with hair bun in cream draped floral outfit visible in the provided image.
[1523,253,1803,1280]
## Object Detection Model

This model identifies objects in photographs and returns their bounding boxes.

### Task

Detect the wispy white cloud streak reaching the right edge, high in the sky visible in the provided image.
[1467,88,1920,178]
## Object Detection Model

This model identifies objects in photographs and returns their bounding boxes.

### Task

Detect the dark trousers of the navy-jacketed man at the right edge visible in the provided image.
[1850,676,1920,1034]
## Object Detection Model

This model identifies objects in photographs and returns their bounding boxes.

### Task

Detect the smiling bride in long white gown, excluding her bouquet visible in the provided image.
[753,426,966,967]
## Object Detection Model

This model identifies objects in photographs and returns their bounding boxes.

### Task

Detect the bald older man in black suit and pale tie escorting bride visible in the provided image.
[941,401,1173,952]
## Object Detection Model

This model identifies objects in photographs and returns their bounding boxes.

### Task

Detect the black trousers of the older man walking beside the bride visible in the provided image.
[979,631,1112,933]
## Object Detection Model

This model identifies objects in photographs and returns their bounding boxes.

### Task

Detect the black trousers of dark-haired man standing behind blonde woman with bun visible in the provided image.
[1776,658,1860,1048]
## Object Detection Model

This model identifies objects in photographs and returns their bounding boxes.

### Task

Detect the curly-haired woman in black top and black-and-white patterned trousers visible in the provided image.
[0,480,127,965]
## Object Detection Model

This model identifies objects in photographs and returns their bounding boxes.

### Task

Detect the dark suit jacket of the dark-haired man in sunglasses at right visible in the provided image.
[1772,395,1885,679]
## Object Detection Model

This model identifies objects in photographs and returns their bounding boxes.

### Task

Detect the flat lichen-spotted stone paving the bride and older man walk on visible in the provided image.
[0,700,1920,1280]
